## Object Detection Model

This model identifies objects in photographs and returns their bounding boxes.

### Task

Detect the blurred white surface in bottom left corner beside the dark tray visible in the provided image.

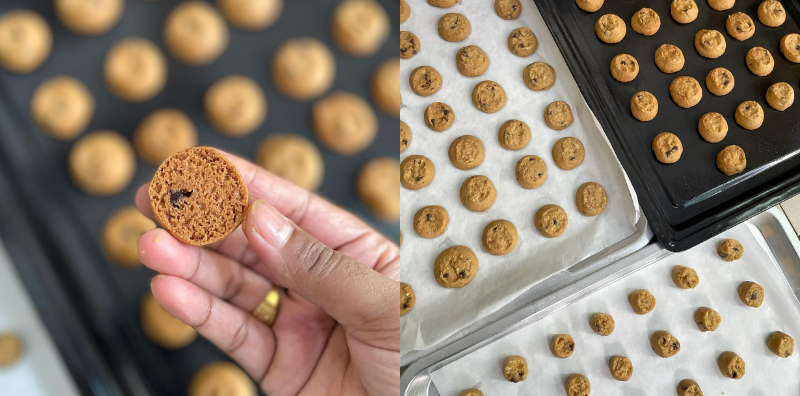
[0,238,78,396]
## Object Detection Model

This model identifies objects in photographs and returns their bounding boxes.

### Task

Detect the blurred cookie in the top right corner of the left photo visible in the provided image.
[331,0,391,57]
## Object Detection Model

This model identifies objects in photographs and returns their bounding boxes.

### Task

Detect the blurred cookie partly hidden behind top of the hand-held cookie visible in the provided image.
[133,109,197,166]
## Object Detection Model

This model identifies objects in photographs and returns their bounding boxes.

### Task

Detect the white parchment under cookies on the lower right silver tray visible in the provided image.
[432,220,800,396]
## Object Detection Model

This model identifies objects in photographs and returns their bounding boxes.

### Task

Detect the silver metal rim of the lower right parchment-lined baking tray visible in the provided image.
[400,207,800,396]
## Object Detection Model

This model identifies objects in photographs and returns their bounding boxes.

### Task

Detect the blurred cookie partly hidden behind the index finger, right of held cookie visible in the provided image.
[255,133,328,194]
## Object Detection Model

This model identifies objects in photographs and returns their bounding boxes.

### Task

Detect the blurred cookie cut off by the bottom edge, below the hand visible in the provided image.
[188,362,258,396]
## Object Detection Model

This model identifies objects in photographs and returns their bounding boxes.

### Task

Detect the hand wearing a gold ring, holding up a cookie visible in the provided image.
[136,153,400,396]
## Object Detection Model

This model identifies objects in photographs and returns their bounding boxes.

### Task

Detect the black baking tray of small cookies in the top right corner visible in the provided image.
[535,0,800,251]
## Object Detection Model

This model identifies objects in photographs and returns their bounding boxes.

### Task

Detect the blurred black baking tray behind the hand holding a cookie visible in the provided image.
[0,0,399,395]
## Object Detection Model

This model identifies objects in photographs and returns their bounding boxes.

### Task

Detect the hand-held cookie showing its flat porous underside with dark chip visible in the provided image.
[148,147,248,246]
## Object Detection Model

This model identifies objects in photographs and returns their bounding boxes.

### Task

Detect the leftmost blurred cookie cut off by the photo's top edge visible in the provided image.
[53,0,125,36]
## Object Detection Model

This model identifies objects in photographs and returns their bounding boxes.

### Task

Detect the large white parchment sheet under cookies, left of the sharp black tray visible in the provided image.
[400,0,639,353]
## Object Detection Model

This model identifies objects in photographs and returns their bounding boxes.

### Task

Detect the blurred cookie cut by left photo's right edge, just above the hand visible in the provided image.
[356,157,400,221]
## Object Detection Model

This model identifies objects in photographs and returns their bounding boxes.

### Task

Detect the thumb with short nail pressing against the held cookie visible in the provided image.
[242,200,399,331]
